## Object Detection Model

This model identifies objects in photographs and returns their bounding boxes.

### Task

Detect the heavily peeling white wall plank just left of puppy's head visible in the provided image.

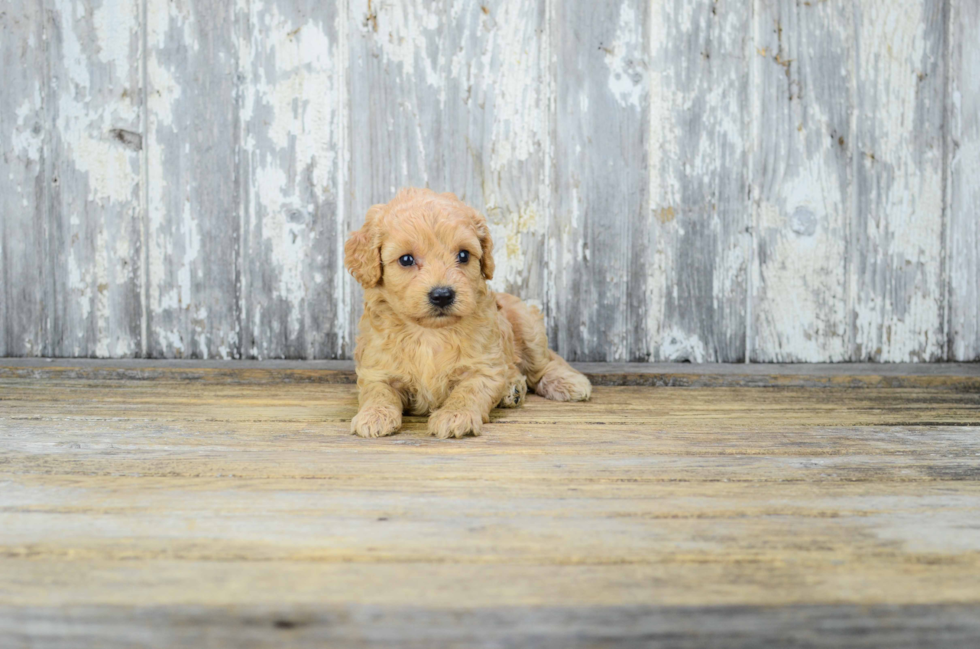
[241,0,348,358]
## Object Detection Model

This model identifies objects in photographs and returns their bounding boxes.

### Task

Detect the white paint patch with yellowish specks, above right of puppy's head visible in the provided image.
[446,0,549,297]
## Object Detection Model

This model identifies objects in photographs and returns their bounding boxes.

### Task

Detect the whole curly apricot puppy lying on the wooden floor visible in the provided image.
[344,189,592,438]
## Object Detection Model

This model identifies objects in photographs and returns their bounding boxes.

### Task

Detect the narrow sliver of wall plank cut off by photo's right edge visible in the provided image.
[946,0,980,361]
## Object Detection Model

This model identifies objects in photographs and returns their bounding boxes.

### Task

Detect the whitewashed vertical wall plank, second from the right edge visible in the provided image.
[849,0,946,361]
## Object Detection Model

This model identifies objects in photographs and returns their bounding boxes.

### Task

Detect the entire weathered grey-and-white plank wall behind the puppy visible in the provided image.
[0,0,980,362]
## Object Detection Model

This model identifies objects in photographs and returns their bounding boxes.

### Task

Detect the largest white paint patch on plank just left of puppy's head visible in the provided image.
[244,3,339,354]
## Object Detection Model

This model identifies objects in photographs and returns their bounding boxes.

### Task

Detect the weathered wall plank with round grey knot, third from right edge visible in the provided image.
[750,0,854,362]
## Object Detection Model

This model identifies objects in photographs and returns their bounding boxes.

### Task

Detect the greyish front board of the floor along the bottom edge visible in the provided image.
[0,604,980,649]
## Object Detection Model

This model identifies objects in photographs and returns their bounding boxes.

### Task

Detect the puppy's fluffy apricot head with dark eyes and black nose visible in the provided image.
[344,189,493,328]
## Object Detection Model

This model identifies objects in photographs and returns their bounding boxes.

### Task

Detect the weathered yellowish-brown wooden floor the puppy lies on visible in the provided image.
[0,361,980,649]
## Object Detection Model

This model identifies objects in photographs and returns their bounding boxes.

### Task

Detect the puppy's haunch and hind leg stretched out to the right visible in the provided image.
[497,293,592,401]
